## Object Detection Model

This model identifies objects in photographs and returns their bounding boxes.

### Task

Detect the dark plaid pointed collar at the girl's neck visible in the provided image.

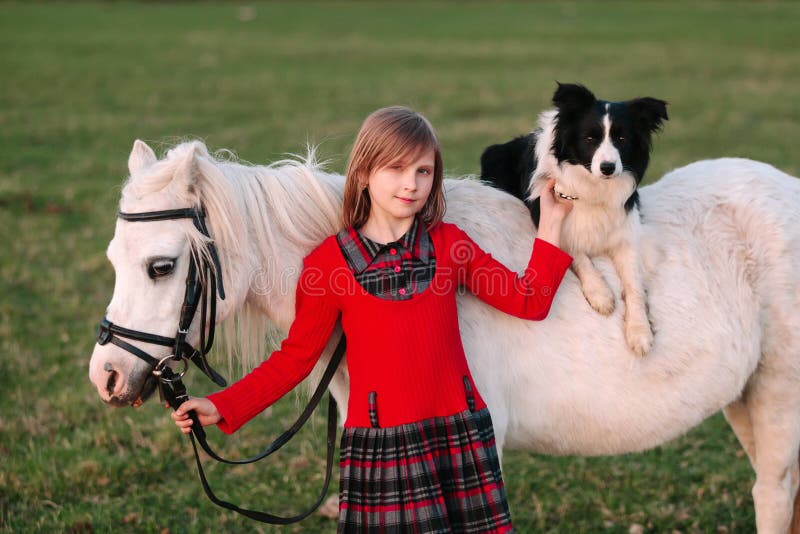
[336,217,433,274]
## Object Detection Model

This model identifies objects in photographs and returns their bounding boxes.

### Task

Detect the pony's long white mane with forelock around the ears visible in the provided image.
[120,141,344,372]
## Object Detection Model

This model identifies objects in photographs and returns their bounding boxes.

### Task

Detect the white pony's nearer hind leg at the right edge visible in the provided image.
[747,376,800,534]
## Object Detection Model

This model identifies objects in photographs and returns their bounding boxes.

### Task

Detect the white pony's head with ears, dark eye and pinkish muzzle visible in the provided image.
[89,140,246,406]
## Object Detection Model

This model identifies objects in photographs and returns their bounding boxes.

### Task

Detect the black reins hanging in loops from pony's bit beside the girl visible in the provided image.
[159,335,346,525]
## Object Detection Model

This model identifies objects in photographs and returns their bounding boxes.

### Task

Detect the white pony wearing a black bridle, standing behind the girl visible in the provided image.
[89,141,800,533]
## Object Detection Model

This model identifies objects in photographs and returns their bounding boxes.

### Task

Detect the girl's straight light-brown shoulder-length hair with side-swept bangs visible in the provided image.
[342,106,445,228]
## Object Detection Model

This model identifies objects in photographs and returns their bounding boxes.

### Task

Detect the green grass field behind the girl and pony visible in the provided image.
[0,2,800,533]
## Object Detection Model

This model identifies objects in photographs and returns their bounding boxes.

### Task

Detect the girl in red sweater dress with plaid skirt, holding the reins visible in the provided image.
[172,107,571,533]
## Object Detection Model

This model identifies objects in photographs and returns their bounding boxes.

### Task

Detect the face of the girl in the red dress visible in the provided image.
[368,149,435,229]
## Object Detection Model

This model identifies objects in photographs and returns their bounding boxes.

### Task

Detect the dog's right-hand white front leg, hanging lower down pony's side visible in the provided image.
[611,242,653,356]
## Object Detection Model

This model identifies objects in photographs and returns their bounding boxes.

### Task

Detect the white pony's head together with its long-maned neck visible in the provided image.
[89,141,344,406]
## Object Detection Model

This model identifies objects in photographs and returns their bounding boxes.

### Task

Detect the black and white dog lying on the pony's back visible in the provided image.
[481,84,668,355]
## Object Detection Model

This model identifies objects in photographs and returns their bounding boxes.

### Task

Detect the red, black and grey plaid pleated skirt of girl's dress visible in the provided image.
[338,409,512,533]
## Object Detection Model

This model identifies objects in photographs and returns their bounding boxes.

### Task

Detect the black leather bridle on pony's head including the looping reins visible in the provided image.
[97,208,345,525]
